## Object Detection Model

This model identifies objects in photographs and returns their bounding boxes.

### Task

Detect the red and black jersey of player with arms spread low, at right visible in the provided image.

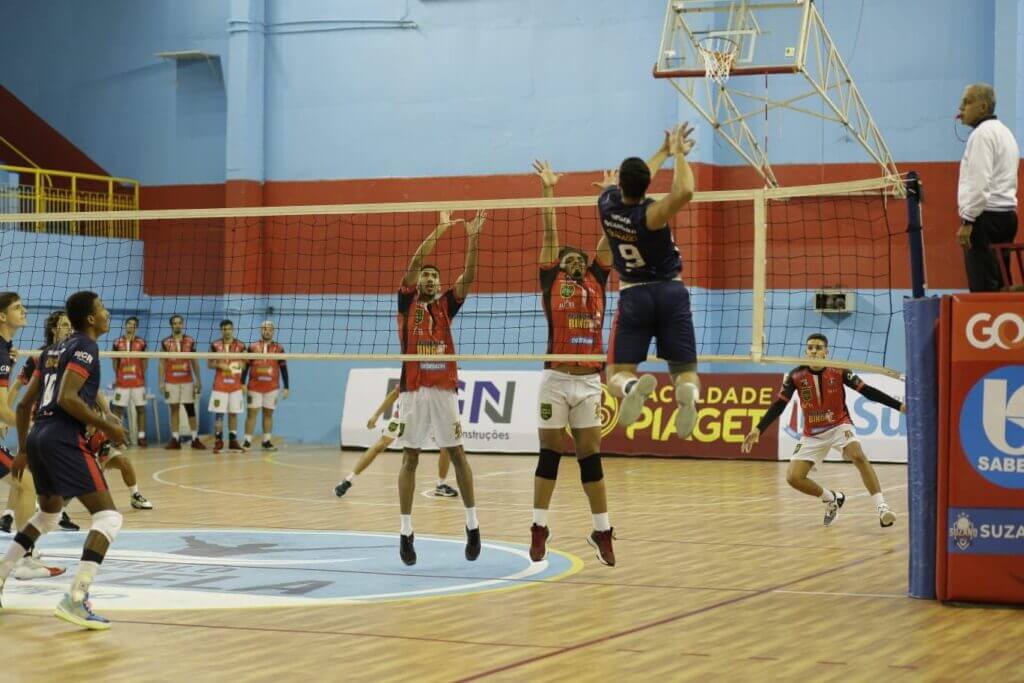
[758,366,903,436]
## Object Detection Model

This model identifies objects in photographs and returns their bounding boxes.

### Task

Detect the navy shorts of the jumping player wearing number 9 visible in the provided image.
[608,280,697,365]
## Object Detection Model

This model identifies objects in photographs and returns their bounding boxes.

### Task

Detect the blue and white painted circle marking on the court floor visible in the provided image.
[3,529,583,613]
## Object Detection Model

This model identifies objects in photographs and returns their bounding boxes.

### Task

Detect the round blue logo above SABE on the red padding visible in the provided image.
[959,366,1024,488]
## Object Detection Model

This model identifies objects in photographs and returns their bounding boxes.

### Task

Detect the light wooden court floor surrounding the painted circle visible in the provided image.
[0,447,1024,681]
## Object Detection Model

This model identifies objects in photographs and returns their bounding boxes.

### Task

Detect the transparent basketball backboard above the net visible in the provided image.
[654,0,811,78]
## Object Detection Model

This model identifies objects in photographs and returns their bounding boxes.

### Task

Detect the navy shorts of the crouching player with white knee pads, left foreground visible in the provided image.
[26,420,108,498]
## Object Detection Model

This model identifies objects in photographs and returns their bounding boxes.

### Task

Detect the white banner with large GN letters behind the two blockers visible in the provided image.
[341,369,541,453]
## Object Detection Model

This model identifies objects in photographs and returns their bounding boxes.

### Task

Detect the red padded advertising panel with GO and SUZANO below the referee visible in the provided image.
[936,294,1024,603]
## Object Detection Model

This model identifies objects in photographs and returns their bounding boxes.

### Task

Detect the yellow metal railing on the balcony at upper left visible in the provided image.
[0,165,138,240]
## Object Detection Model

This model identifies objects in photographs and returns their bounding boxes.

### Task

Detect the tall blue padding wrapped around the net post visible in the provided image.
[903,297,940,600]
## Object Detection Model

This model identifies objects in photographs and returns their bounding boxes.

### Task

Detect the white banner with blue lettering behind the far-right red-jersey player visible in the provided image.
[778,375,906,463]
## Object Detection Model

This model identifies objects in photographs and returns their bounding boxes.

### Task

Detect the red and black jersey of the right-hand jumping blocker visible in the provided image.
[541,260,610,370]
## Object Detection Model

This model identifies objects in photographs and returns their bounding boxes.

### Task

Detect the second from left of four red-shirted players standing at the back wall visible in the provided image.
[160,314,206,451]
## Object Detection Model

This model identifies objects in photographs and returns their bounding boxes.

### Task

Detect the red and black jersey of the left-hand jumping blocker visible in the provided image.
[398,286,465,391]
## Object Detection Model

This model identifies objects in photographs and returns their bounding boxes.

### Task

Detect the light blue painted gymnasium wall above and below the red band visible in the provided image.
[0,0,1024,441]
